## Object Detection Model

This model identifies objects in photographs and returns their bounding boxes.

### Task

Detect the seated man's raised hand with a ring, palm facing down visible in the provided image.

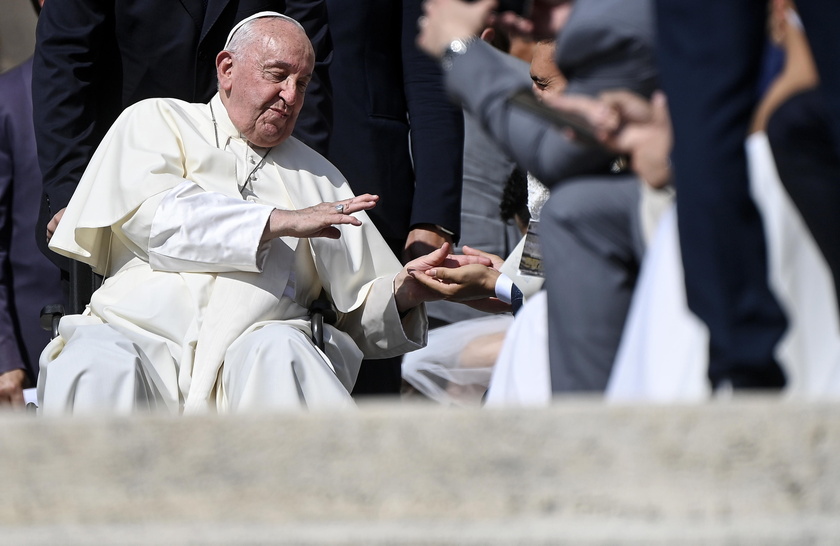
[262,193,379,241]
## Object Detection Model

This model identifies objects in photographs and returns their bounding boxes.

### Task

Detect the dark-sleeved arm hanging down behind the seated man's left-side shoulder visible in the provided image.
[32,0,121,233]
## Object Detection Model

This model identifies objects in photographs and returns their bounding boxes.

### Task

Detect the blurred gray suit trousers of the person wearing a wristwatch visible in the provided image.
[539,175,644,388]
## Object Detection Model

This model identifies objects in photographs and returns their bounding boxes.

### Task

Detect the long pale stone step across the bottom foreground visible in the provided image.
[0,397,840,545]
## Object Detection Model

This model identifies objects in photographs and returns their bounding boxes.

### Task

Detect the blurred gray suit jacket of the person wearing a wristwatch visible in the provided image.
[446,0,657,186]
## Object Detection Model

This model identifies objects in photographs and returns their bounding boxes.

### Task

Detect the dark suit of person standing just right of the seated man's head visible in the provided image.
[327,0,464,256]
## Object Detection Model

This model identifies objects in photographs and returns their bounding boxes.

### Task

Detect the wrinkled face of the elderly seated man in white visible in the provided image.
[216,18,315,148]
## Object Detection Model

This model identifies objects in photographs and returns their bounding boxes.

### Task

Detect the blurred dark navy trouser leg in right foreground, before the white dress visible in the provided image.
[657,0,812,388]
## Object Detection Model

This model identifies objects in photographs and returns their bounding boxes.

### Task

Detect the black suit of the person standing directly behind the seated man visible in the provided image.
[33,0,331,270]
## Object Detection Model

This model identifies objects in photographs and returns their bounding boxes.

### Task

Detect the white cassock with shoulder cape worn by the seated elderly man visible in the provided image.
[38,95,427,413]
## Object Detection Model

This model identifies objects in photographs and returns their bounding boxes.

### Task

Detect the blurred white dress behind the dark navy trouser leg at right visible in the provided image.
[607,133,840,402]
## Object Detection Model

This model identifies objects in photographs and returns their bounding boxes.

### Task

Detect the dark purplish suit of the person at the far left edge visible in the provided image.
[0,60,61,381]
